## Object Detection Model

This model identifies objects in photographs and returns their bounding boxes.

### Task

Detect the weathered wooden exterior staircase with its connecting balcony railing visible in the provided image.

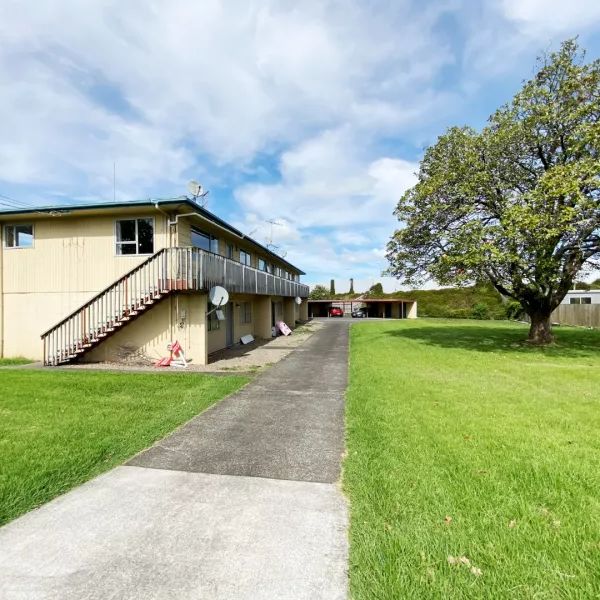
[41,247,308,366]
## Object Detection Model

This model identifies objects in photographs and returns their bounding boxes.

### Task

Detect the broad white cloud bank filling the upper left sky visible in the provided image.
[0,0,452,196]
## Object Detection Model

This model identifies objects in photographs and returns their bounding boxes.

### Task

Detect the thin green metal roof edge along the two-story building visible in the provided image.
[0,196,306,275]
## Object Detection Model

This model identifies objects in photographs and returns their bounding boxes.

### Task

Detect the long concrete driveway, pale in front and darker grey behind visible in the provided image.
[0,320,348,600]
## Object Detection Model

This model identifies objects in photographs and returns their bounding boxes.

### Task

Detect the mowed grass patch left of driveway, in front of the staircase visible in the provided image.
[0,369,248,525]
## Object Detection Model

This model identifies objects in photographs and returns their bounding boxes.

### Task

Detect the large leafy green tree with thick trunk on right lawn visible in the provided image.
[387,40,600,344]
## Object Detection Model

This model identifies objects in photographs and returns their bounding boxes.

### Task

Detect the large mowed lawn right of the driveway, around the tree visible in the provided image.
[344,320,600,600]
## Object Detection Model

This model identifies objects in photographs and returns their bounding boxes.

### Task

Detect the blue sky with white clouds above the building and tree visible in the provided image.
[0,0,600,291]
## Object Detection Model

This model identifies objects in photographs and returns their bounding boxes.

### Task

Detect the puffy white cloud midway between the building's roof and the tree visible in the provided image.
[236,129,418,228]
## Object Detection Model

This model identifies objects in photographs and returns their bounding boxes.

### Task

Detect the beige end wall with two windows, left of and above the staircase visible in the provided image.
[0,208,169,360]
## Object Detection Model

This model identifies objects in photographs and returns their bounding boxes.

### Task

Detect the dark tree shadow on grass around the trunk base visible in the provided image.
[388,322,600,358]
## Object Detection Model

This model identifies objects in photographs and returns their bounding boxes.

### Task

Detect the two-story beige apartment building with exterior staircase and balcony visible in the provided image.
[0,197,308,364]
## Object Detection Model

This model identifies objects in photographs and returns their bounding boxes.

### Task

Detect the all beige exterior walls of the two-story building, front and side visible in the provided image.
[0,207,304,361]
